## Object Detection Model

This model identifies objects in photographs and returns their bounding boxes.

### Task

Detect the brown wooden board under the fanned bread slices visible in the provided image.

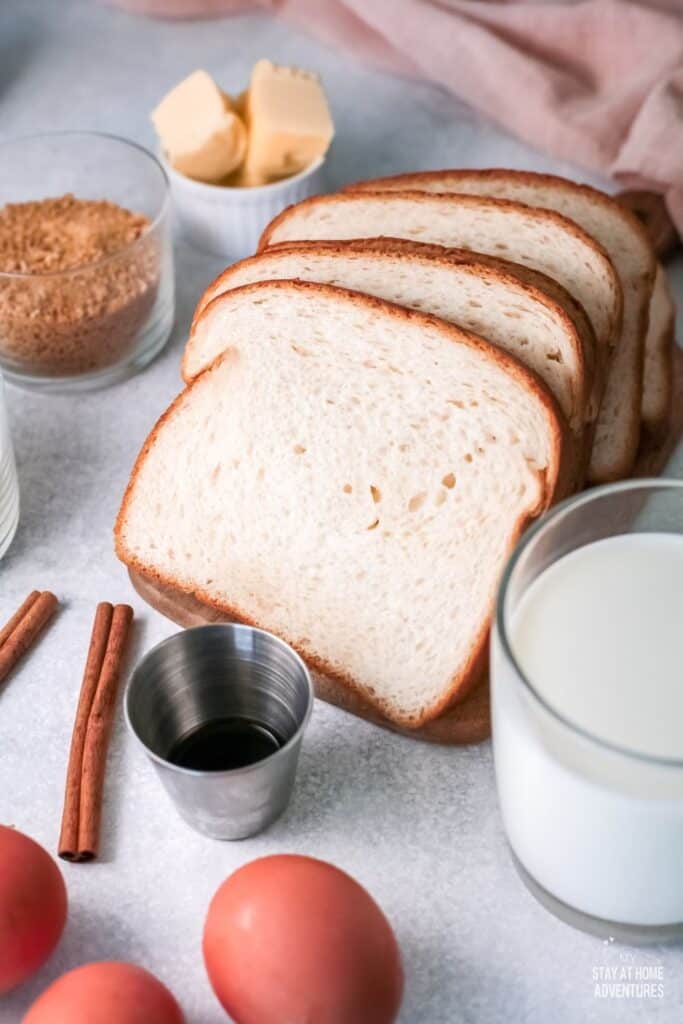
[130,348,683,746]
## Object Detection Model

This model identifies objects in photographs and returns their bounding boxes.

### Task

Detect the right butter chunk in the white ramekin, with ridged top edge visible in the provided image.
[238,60,334,185]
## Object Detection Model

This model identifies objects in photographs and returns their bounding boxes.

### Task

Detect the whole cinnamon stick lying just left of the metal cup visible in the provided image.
[58,602,133,862]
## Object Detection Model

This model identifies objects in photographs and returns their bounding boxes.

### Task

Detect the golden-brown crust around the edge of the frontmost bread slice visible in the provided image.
[114,281,568,728]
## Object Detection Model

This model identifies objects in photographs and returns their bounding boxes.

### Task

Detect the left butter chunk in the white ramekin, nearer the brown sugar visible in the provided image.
[152,71,247,182]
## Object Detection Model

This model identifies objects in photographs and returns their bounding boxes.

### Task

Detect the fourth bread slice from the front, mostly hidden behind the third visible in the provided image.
[351,169,655,483]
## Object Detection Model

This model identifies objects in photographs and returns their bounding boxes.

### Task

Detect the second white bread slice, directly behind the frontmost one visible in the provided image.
[182,242,588,447]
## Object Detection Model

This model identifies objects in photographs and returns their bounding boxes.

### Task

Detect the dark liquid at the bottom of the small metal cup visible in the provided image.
[167,718,286,771]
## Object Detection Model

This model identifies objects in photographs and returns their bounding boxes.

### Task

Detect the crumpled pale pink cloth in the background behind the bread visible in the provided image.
[109,0,683,233]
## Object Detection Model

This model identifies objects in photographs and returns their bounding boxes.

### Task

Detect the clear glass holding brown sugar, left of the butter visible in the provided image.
[0,131,174,391]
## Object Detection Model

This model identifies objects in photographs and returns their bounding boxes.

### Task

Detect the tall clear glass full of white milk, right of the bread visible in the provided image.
[492,479,683,942]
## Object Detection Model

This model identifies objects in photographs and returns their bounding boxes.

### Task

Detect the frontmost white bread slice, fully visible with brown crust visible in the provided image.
[116,282,566,727]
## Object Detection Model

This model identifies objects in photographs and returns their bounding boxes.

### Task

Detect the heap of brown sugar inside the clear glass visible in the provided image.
[0,196,161,377]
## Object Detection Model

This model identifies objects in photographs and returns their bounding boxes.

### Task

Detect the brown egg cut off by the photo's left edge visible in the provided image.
[0,825,67,994]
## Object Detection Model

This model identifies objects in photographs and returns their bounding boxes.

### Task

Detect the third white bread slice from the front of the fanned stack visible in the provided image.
[259,190,622,428]
